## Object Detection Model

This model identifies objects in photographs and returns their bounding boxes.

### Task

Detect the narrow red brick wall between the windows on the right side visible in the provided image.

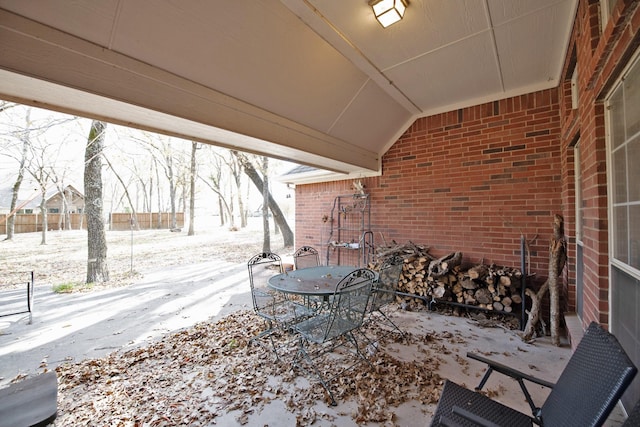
[559,0,640,327]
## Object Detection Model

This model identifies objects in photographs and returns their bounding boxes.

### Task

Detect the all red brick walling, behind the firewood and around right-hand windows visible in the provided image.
[296,0,640,334]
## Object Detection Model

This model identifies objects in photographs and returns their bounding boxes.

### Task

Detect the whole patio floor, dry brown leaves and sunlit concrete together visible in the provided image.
[0,256,612,426]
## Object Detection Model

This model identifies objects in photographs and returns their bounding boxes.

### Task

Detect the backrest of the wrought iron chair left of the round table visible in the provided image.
[247,252,283,313]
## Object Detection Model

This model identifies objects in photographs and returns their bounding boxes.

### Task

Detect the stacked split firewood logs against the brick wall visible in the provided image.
[377,242,522,313]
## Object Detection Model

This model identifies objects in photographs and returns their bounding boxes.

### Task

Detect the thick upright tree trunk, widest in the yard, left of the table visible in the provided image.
[84,120,109,283]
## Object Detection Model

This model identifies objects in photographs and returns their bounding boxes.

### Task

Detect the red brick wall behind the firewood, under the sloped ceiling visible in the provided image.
[296,90,562,282]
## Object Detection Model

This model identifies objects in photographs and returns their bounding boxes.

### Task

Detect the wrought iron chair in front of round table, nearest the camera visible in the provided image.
[293,268,375,406]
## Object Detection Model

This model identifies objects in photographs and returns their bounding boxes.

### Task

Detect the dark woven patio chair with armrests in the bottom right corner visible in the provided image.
[431,322,637,427]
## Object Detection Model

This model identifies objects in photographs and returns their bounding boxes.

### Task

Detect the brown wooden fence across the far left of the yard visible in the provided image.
[0,212,184,234]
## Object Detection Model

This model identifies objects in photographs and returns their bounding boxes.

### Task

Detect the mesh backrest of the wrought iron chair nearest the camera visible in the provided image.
[324,268,376,341]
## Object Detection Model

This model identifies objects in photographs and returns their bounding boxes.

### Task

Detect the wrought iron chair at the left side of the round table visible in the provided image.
[247,252,311,360]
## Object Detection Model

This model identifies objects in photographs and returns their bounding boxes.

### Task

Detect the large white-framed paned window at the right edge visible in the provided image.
[606,49,640,408]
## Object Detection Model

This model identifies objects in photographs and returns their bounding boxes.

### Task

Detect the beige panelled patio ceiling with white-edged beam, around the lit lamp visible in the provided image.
[0,0,577,181]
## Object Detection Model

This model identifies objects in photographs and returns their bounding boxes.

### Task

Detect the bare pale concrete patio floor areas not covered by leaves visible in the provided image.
[0,261,623,426]
